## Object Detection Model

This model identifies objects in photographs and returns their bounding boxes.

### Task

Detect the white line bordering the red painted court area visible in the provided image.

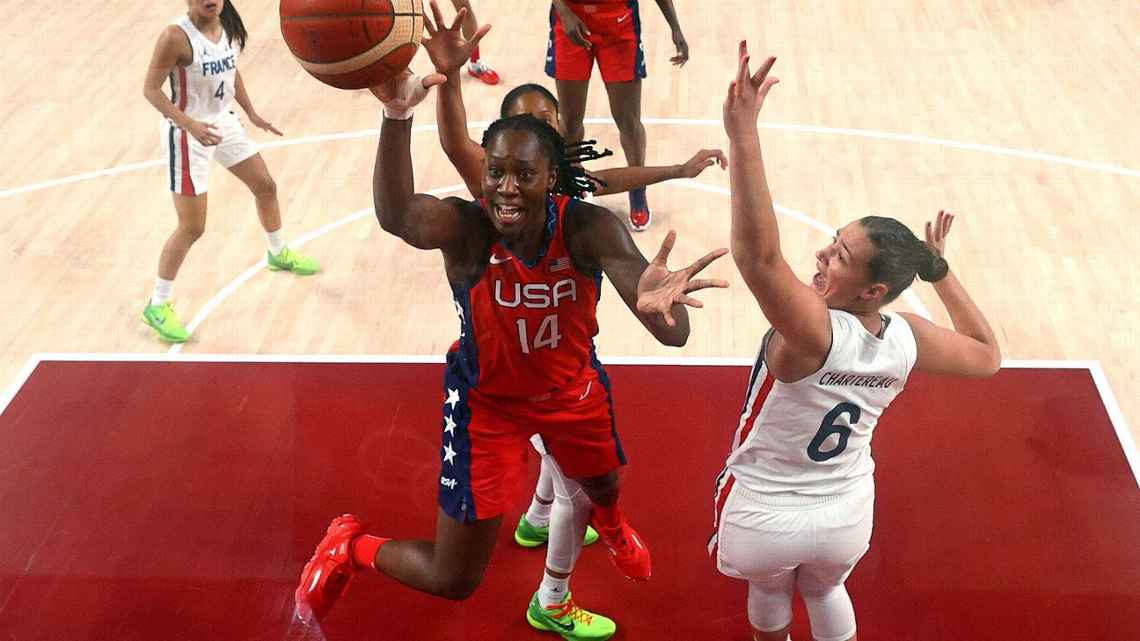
[0,352,1140,487]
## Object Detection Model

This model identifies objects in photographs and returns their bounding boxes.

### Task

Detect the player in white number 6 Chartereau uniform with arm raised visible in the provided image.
[709,42,1001,641]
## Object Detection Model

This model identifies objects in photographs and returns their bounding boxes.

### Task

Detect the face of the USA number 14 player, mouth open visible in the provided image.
[483,130,555,236]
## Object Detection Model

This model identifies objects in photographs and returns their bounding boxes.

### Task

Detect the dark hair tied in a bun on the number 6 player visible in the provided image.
[860,216,950,305]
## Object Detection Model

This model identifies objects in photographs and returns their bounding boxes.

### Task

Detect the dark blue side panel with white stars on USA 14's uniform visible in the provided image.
[439,286,479,522]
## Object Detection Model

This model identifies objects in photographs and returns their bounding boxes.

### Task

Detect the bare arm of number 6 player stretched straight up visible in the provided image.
[724,42,831,362]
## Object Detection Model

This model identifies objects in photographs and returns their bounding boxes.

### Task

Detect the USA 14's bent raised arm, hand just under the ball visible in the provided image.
[372,71,464,251]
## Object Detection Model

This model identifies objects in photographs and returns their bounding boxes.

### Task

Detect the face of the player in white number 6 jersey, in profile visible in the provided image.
[812,224,881,308]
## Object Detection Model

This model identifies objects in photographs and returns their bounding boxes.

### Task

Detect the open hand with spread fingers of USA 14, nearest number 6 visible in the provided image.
[637,229,728,327]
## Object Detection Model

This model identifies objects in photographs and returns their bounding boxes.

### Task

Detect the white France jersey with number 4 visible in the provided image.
[170,15,238,123]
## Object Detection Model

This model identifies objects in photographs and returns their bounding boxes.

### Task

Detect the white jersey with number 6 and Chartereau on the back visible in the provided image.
[716,309,918,505]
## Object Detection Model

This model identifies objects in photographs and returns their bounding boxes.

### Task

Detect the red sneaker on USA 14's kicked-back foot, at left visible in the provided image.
[294,514,365,622]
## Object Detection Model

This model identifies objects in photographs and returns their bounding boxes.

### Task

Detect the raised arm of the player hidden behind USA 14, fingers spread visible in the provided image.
[423,1,490,198]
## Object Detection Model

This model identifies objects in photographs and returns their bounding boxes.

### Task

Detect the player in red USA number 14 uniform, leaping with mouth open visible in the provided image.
[296,56,727,639]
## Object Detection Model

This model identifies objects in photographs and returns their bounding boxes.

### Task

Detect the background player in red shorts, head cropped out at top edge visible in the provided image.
[546,0,689,230]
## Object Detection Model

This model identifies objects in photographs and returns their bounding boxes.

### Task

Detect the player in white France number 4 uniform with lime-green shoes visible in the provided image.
[143,0,319,342]
